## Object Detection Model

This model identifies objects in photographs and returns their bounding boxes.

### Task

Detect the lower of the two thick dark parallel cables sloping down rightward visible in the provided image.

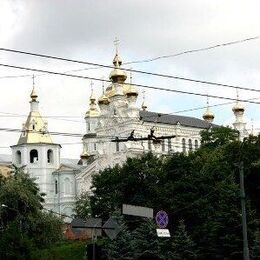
[0,63,260,105]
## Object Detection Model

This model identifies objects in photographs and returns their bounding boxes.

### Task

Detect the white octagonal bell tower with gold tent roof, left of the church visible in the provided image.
[11,77,61,209]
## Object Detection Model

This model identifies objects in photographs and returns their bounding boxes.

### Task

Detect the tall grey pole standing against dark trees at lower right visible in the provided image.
[239,162,249,260]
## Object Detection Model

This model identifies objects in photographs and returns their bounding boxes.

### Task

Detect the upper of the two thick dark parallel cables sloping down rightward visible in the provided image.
[0,48,260,92]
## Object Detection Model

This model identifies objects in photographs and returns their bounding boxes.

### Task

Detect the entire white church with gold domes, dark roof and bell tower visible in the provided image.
[11,48,247,215]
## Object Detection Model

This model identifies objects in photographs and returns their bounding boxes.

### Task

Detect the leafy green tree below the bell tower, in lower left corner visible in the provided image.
[0,168,62,259]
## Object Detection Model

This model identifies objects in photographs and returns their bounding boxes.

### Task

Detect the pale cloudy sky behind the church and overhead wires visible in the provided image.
[0,0,260,157]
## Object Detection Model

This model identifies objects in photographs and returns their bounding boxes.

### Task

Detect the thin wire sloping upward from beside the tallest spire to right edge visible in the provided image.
[124,36,260,64]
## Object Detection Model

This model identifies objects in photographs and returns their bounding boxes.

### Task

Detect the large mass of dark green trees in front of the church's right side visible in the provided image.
[84,130,260,259]
